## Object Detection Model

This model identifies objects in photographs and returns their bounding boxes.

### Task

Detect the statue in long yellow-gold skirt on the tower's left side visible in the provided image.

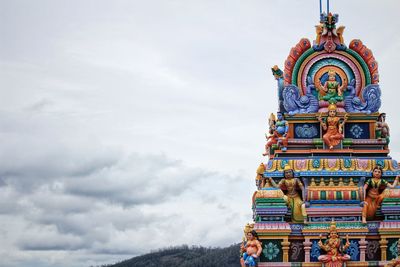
[269,166,307,223]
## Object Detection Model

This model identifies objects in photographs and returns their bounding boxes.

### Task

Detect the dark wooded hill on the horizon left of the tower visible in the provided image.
[103,244,240,267]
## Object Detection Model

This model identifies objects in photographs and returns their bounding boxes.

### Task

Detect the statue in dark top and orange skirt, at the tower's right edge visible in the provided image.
[362,165,399,223]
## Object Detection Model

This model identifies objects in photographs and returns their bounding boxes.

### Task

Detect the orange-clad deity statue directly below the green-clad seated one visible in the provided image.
[318,104,347,150]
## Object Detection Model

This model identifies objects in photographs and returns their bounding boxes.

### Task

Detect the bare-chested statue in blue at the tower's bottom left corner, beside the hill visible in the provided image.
[240,230,262,267]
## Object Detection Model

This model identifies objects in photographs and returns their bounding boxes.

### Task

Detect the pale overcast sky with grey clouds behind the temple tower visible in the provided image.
[0,0,400,267]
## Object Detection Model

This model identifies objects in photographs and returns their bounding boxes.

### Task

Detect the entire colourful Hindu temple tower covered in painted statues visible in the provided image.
[240,13,400,267]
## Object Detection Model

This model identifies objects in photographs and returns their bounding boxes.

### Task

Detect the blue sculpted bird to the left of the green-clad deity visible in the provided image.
[283,77,318,115]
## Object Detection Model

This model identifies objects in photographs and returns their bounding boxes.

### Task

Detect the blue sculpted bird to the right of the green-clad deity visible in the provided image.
[344,79,381,114]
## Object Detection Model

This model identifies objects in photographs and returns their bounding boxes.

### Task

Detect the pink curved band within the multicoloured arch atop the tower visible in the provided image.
[301,53,362,96]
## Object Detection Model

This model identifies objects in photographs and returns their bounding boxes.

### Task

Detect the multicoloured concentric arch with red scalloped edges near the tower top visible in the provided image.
[284,39,379,95]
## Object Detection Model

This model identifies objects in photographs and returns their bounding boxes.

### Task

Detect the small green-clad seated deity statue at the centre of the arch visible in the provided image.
[316,70,346,104]
